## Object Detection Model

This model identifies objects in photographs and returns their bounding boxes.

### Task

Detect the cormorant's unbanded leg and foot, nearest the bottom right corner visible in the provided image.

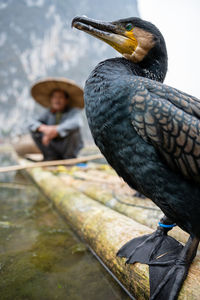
[150,236,199,300]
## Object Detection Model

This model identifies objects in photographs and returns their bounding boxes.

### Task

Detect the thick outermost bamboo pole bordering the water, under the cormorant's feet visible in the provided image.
[28,168,200,300]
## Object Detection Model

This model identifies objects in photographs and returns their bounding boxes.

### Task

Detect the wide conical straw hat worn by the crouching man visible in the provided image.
[31,78,84,108]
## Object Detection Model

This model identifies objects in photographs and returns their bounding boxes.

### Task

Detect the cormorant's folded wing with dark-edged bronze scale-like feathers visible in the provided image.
[129,77,200,182]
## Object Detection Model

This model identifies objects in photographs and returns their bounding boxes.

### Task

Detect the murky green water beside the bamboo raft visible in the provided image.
[0,151,129,300]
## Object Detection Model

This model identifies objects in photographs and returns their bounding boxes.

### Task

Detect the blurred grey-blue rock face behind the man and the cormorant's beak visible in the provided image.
[0,0,138,139]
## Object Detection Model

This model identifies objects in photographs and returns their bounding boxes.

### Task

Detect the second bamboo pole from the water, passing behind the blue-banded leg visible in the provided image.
[61,172,189,243]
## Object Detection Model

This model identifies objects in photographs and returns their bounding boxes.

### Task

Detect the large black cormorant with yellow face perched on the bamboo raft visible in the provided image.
[72,17,200,300]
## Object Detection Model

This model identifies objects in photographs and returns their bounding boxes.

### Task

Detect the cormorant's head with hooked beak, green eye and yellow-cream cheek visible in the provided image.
[72,17,167,63]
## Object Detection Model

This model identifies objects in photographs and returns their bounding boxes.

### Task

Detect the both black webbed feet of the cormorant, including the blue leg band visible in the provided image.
[117,217,199,300]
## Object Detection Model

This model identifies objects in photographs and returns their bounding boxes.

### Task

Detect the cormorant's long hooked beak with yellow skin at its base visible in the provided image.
[72,17,138,56]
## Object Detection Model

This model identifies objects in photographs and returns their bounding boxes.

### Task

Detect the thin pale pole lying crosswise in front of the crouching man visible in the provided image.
[0,154,103,173]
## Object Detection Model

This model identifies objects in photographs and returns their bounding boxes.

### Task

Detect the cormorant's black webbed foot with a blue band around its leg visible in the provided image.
[117,216,183,264]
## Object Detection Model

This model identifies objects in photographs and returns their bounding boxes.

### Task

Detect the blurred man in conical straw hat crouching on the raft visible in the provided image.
[29,78,84,160]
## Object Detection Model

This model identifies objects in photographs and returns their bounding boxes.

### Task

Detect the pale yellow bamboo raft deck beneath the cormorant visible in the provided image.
[23,164,200,300]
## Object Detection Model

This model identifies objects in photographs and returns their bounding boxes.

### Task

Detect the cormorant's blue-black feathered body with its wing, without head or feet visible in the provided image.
[85,58,200,238]
